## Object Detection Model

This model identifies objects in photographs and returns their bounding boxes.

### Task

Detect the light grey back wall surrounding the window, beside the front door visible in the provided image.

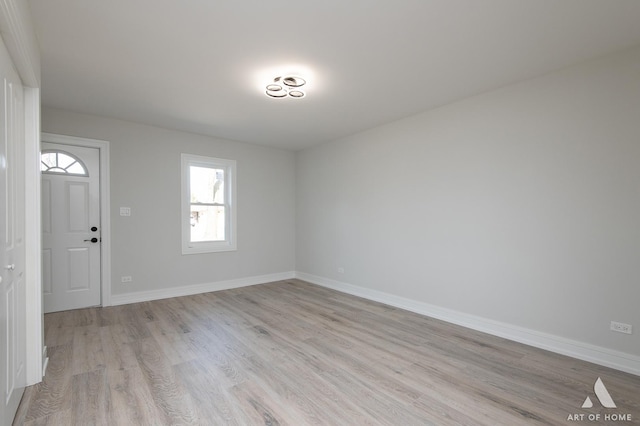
[42,108,295,295]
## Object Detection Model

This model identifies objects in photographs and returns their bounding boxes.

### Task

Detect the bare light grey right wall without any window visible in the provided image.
[296,48,640,359]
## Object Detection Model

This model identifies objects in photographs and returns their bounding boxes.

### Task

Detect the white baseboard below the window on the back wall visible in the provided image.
[111,272,295,306]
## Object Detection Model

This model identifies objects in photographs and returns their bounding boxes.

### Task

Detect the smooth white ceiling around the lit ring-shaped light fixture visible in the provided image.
[29,0,640,149]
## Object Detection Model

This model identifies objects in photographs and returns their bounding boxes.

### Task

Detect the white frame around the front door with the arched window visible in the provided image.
[40,133,111,306]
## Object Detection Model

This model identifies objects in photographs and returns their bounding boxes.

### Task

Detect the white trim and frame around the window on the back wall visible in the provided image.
[181,154,238,254]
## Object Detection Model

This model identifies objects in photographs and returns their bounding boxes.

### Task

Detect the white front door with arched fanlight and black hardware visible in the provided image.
[41,142,101,312]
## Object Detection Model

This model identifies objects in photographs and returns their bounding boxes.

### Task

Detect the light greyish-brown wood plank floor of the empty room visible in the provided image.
[15,280,640,426]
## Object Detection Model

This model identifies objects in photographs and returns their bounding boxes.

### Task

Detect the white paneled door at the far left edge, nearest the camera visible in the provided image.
[0,35,27,424]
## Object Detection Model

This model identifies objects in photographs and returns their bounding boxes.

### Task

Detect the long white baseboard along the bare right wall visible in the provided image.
[295,272,640,376]
